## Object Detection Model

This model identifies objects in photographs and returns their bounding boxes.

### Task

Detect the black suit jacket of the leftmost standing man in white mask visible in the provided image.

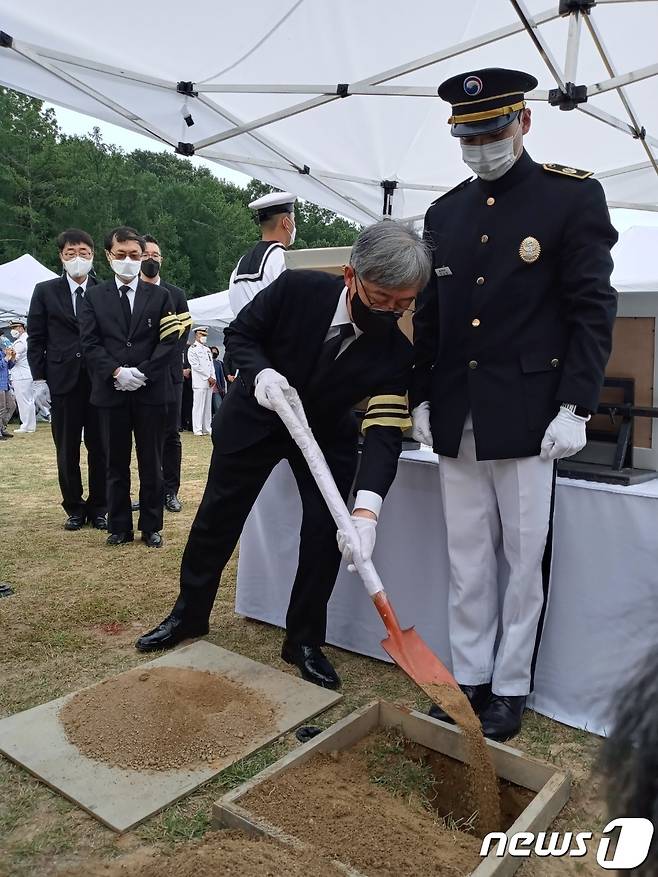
[27,274,96,395]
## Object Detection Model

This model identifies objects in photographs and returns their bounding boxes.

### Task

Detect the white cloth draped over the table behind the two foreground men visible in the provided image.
[235,451,658,734]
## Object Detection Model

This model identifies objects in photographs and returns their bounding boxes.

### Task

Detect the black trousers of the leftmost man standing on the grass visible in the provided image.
[50,369,106,518]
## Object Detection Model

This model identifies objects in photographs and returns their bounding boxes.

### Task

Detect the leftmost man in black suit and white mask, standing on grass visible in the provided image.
[27,228,107,530]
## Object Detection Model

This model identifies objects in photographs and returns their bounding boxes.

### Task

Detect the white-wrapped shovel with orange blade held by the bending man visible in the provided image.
[271,387,459,699]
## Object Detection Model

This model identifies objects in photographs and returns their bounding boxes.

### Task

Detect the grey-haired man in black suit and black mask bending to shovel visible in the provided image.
[136,221,430,688]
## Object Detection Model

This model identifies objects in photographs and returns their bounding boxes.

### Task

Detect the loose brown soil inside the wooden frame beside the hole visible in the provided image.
[238,735,481,877]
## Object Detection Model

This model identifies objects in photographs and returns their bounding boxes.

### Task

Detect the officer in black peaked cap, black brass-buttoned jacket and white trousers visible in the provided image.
[412,68,617,740]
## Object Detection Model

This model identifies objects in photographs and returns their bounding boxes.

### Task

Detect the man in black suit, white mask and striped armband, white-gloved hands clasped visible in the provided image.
[80,227,179,548]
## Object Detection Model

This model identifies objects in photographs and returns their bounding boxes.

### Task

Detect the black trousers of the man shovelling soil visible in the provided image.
[173,424,357,646]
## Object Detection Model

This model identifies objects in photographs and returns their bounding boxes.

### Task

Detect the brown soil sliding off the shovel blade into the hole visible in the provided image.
[421,683,500,837]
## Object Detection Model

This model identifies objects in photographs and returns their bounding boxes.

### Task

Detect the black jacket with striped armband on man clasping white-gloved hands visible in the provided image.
[78,278,179,407]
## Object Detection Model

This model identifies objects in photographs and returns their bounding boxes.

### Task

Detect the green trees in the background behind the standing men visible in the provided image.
[0,89,358,297]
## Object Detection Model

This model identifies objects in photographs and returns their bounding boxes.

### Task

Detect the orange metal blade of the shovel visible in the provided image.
[373,591,459,688]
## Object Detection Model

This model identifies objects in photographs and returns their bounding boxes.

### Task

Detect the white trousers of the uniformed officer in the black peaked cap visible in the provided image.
[439,416,553,695]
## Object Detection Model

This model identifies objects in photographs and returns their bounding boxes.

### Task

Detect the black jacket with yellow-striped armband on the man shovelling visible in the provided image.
[223,271,413,497]
